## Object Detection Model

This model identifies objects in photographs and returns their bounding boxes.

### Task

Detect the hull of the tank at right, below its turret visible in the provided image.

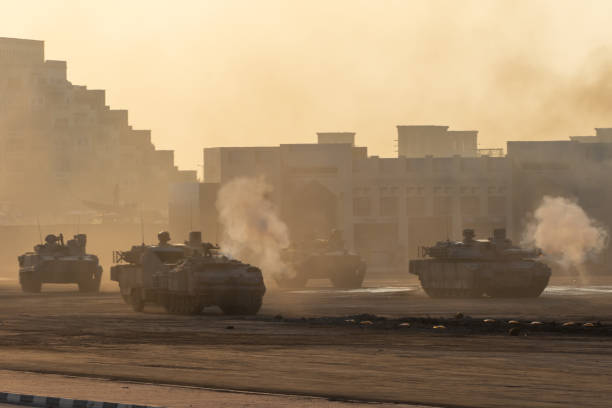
[410,259,551,298]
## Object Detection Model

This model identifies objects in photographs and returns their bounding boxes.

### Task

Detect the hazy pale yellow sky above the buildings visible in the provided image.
[0,0,612,174]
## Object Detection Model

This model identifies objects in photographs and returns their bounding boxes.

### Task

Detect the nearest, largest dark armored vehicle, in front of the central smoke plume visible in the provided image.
[111,231,266,315]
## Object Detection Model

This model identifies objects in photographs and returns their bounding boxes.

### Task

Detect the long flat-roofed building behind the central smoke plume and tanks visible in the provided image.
[170,127,513,267]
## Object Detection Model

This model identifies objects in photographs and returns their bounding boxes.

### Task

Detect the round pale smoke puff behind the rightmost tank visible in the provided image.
[523,196,608,271]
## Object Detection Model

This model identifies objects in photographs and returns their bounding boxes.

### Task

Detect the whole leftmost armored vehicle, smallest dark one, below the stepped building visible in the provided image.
[17,234,102,293]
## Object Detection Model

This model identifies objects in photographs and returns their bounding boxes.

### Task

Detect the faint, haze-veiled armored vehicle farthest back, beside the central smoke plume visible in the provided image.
[275,230,366,289]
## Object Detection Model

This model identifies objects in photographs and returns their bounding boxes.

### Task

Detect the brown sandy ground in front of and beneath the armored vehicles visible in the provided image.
[0,279,612,407]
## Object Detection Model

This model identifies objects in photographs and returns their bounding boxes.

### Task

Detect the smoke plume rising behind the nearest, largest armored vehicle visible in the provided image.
[216,178,290,276]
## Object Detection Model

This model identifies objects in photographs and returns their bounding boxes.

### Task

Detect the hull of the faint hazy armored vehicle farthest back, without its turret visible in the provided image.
[275,253,366,289]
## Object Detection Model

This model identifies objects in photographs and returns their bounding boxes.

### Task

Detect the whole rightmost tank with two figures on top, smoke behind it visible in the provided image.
[409,229,550,298]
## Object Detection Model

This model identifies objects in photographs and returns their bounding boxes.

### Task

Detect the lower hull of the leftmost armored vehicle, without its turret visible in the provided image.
[19,254,102,292]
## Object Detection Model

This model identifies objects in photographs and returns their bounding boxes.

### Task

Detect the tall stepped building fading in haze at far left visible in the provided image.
[0,38,196,223]
